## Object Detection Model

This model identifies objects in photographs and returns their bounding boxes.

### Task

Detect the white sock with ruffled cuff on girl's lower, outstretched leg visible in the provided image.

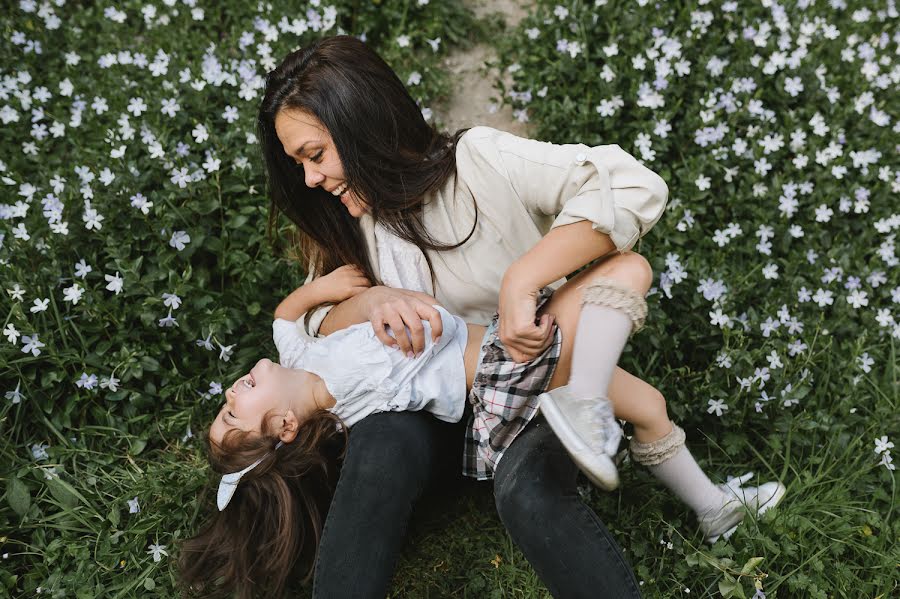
[631,423,727,516]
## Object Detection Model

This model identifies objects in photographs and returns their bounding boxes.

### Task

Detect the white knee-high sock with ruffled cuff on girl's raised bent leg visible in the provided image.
[568,278,647,398]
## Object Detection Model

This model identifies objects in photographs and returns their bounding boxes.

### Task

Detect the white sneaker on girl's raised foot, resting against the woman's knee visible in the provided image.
[538,387,622,491]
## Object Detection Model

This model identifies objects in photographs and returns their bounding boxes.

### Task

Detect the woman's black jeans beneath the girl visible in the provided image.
[313,412,640,599]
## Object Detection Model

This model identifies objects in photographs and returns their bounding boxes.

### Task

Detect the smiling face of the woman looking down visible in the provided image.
[275,108,369,218]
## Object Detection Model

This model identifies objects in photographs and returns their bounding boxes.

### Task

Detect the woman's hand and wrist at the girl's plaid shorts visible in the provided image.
[498,277,554,363]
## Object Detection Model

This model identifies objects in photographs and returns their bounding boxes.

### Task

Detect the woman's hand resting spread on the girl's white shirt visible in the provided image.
[365,286,444,357]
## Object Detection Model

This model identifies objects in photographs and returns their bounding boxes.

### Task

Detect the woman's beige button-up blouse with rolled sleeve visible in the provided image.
[306,127,668,334]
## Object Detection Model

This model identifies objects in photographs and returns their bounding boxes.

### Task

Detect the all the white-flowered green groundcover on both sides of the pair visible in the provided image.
[0,0,900,598]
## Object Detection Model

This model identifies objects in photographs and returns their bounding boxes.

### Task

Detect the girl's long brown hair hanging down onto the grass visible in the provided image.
[178,410,347,599]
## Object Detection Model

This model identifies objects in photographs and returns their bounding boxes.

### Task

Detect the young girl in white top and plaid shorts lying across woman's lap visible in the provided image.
[182,254,785,596]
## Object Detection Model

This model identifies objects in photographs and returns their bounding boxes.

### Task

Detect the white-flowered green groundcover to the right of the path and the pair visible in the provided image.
[499,0,900,597]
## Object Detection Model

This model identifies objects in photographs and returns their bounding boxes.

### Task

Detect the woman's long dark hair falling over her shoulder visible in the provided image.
[257,35,478,290]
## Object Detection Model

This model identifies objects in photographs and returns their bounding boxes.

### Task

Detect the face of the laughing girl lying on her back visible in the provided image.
[209,358,297,443]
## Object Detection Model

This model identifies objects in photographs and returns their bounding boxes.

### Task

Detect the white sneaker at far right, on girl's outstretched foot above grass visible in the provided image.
[697,472,787,544]
